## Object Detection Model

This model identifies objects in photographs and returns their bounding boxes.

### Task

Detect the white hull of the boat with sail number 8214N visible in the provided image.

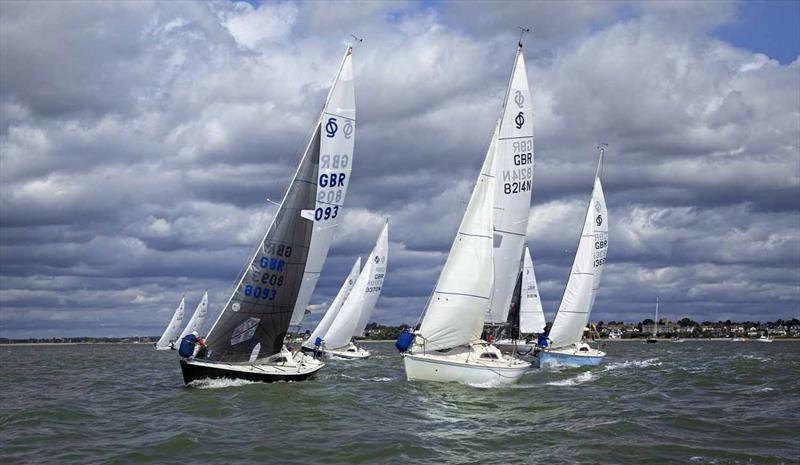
[403,344,531,386]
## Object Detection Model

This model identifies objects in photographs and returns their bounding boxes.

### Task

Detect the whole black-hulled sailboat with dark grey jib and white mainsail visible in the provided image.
[180,47,355,384]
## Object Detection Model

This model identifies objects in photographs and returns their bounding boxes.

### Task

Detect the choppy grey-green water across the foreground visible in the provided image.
[0,342,800,465]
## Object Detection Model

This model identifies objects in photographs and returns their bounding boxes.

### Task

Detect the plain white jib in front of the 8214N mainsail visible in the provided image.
[414,132,497,350]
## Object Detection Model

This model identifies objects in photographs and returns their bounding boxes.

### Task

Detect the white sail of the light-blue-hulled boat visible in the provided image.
[548,150,608,348]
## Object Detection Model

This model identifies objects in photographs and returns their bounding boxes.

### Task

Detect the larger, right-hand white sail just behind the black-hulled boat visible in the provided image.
[323,222,389,349]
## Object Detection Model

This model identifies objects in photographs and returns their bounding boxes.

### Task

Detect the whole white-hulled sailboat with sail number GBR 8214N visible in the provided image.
[396,41,533,385]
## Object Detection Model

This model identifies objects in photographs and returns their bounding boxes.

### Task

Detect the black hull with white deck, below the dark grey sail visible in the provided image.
[180,354,325,384]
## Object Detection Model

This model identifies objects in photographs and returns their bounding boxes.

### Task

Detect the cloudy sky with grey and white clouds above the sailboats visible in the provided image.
[0,1,800,337]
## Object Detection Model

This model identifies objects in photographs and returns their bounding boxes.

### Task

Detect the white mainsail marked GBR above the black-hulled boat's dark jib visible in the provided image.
[290,49,356,326]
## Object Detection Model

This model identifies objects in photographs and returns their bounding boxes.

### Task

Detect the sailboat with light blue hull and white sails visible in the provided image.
[537,144,608,367]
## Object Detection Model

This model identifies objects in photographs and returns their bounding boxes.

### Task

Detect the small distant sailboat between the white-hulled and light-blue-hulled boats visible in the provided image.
[494,247,545,355]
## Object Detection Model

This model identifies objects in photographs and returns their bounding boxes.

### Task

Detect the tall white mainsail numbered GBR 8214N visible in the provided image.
[486,45,533,324]
